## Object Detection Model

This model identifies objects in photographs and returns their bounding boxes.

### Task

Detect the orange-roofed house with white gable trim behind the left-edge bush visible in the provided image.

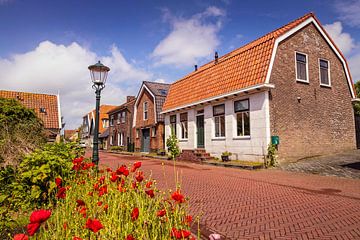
[0,90,63,142]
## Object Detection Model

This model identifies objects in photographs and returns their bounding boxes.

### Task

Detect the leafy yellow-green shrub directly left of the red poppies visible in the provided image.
[0,143,83,235]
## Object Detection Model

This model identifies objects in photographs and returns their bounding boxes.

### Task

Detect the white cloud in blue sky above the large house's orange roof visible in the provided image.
[151,6,225,67]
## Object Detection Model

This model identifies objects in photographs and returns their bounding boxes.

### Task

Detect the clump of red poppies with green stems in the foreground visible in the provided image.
[13,157,195,240]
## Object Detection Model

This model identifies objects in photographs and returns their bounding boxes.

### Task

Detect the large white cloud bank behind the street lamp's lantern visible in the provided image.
[0,41,152,129]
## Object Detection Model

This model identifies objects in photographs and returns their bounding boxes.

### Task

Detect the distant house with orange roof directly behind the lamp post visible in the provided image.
[81,105,116,148]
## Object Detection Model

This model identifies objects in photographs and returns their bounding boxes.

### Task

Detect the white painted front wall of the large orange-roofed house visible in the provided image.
[165,92,270,160]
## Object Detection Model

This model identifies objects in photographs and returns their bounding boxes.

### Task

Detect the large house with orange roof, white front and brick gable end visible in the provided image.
[163,13,355,160]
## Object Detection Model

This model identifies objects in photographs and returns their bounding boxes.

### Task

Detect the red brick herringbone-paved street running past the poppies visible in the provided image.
[95,152,360,239]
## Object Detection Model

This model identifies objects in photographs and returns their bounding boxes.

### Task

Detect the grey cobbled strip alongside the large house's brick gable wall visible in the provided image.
[279,150,360,179]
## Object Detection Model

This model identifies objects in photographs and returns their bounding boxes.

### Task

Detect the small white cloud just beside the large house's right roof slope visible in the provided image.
[324,22,355,55]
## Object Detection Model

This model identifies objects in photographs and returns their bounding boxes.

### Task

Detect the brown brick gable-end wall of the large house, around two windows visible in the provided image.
[270,25,355,159]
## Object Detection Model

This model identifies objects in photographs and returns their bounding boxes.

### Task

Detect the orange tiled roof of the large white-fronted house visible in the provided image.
[163,13,354,111]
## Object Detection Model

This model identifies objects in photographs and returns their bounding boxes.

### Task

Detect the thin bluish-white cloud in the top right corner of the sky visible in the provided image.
[335,0,360,27]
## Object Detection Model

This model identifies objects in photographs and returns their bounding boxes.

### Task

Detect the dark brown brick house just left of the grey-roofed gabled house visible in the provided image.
[107,96,135,151]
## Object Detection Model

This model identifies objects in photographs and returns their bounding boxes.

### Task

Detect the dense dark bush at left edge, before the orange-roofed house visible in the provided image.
[0,98,46,165]
